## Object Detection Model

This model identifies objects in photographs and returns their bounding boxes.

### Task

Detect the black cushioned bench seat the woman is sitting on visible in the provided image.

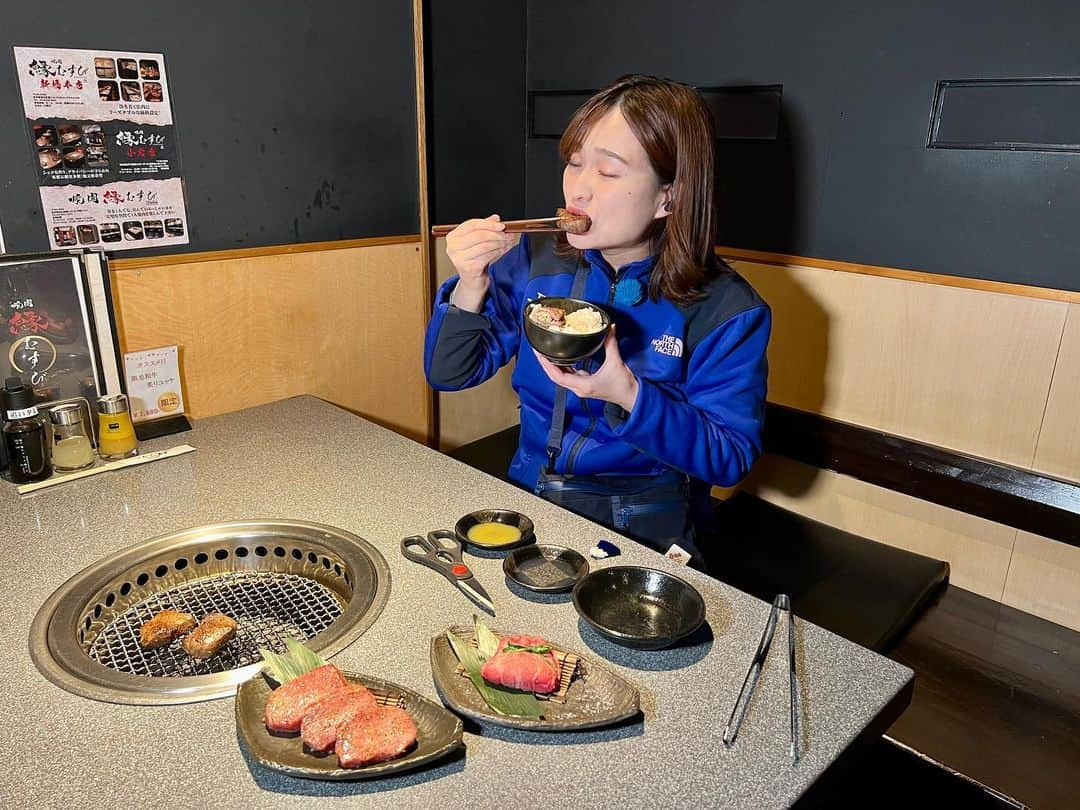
[448,426,948,651]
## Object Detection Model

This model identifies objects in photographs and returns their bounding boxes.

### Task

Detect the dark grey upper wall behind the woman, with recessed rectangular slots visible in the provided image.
[526,0,1080,291]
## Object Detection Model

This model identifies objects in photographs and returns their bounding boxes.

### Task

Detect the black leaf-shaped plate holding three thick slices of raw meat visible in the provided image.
[237,672,463,781]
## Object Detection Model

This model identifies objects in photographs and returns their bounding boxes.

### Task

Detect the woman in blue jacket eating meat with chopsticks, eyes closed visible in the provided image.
[424,76,771,566]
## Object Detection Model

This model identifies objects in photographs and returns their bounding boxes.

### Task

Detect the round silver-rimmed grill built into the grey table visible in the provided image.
[30,521,390,704]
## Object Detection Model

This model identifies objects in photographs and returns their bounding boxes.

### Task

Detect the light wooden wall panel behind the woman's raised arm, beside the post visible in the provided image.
[429,239,517,450]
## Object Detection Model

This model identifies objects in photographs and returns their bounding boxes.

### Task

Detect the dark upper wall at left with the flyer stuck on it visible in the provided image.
[0,0,419,255]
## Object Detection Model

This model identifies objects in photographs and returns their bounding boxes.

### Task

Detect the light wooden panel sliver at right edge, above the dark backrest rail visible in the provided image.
[1034,303,1080,482]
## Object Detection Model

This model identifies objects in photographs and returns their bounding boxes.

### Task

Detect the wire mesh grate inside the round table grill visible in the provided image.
[87,571,342,677]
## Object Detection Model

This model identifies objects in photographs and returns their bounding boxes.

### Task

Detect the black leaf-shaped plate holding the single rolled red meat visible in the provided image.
[431,626,640,731]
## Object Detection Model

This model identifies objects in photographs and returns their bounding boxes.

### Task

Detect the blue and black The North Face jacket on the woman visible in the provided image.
[423,234,771,489]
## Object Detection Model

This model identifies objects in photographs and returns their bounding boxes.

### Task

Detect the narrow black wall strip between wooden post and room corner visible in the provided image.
[424,0,526,224]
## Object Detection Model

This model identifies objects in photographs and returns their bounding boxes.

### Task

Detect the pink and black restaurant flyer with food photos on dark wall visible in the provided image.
[15,46,188,251]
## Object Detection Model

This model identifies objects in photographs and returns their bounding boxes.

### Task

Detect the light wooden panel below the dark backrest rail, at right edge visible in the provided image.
[1002,531,1080,631]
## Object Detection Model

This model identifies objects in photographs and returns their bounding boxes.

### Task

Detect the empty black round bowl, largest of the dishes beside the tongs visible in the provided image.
[573,566,705,650]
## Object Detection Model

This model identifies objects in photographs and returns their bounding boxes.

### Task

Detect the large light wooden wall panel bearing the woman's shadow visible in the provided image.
[734,261,1069,467]
